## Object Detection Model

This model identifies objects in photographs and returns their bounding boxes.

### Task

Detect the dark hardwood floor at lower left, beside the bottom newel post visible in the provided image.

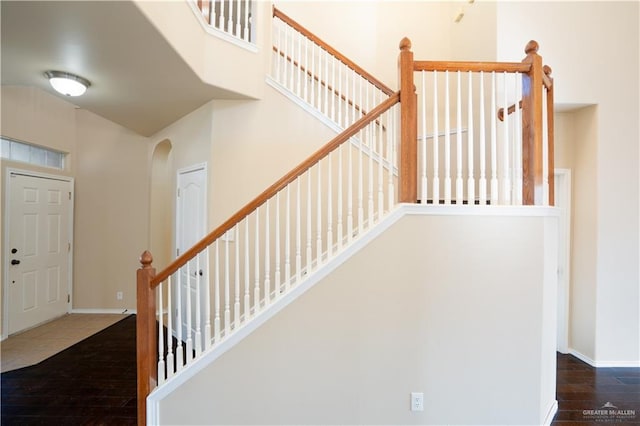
[0,315,137,426]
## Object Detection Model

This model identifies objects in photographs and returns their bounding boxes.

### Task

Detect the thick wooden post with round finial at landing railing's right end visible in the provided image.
[522,40,544,205]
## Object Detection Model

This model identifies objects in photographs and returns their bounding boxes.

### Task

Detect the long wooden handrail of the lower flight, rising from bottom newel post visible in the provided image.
[150,92,400,288]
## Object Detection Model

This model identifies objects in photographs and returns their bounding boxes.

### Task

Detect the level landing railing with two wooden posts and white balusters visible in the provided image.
[399,39,554,205]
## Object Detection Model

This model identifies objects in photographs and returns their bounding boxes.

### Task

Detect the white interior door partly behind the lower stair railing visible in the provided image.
[174,164,207,350]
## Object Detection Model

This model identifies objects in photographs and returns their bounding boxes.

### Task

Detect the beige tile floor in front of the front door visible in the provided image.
[0,314,128,373]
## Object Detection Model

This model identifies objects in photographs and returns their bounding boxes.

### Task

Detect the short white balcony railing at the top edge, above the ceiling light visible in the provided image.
[190,0,253,42]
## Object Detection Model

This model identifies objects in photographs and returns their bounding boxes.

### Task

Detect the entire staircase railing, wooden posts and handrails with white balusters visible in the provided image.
[137,2,553,424]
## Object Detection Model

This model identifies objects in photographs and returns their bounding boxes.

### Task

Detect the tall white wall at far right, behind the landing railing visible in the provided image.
[497,1,640,365]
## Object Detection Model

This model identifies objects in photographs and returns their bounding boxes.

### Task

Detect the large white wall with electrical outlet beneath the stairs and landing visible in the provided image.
[160,209,557,424]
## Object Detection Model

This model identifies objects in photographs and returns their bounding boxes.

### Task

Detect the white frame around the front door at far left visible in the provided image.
[2,168,75,340]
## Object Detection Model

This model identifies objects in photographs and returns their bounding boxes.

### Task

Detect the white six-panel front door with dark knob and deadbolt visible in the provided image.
[5,170,73,334]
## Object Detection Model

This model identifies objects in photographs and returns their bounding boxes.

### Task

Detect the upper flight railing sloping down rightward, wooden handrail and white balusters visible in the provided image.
[271,7,394,129]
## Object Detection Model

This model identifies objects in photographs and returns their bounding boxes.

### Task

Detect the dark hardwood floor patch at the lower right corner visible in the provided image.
[552,354,640,426]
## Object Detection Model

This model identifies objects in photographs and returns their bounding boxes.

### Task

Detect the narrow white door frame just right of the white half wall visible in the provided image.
[554,169,571,353]
